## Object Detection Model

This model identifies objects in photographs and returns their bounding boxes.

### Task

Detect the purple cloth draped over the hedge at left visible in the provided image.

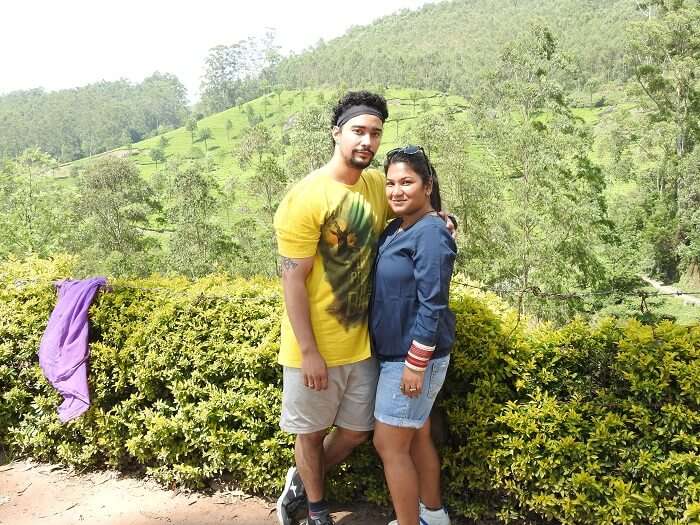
[39,277,107,423]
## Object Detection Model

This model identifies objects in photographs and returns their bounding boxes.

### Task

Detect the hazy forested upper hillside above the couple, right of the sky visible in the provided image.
[277,0,639,95]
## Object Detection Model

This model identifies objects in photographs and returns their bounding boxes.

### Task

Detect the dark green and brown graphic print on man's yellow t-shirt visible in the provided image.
[318,192,376,330]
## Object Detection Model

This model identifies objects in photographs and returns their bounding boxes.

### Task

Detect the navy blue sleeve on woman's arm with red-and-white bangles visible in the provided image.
[411,224,457,347]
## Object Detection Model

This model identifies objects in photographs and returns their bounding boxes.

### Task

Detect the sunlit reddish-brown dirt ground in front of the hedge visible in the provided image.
[0,460,389,525]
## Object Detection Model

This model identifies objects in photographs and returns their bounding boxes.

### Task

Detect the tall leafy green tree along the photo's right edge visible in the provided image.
[627,0,700,281]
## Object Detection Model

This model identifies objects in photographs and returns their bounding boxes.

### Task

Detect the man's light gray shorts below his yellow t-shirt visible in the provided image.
[280,357,379,434]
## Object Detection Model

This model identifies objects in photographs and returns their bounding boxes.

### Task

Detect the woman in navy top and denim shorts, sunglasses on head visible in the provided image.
[370,146,457,525]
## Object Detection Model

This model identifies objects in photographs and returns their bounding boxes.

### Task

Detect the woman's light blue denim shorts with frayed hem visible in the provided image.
[374,355,450,428]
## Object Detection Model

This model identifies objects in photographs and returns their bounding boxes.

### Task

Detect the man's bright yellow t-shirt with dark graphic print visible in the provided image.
[274,168,388,368]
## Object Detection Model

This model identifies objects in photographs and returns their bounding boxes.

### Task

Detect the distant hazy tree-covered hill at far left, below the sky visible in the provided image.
[0,73,188,161]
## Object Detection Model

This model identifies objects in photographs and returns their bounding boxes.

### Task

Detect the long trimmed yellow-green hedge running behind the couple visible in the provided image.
[0,258,700,525]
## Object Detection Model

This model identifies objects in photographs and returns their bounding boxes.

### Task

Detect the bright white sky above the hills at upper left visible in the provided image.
[0,0,429,100]
